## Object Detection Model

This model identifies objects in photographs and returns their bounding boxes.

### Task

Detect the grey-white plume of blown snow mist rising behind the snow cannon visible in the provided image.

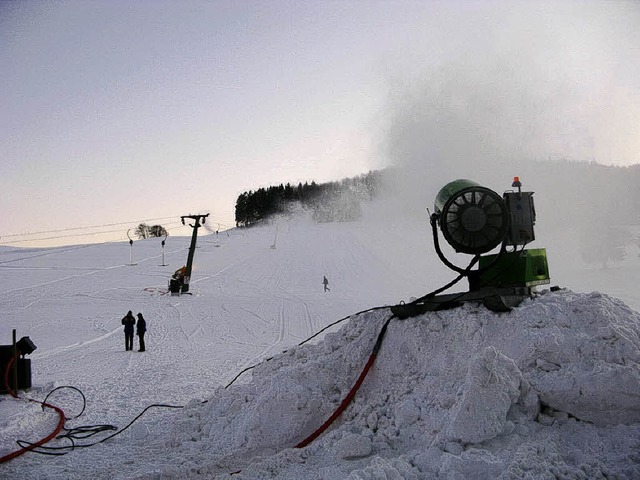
[368,2,640,284]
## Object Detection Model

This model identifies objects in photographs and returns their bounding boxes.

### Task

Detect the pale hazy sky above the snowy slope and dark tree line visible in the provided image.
[0,0,640,246]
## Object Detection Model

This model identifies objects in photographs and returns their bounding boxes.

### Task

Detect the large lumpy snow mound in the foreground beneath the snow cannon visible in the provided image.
[121,290,640,479]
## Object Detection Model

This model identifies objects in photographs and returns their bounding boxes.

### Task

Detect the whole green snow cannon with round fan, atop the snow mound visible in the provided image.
[392,177,550,318]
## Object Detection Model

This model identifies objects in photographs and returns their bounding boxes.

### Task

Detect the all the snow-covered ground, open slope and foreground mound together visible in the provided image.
[0,211,640,479]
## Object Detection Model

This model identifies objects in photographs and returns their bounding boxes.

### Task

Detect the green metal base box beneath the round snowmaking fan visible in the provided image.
[477,248,550,287]
